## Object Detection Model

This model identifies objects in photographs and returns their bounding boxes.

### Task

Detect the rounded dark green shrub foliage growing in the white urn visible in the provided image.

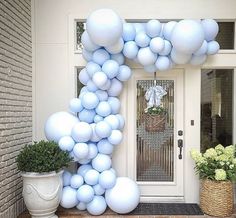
[16,140,72,173]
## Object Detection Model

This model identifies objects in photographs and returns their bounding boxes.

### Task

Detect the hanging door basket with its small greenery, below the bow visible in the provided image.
[144,106,166,132]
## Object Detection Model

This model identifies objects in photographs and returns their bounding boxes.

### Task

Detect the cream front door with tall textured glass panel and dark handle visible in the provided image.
[126,69,184,202]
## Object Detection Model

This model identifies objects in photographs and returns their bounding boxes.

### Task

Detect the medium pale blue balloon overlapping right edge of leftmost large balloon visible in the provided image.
[71,122,93,142]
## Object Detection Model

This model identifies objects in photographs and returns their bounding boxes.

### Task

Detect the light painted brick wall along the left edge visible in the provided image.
[0,0,32,218]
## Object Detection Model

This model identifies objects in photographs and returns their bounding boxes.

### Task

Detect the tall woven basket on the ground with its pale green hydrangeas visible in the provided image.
[191,145,236,216]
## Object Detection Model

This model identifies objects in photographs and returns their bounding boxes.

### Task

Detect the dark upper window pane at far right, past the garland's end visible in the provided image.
[216,22,234,49]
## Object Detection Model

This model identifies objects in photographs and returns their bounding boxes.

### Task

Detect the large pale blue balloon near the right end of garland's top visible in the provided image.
[171,20,204,54]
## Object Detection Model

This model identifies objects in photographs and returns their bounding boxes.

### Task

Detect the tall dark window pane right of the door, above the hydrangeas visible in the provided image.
[201,69,233,151]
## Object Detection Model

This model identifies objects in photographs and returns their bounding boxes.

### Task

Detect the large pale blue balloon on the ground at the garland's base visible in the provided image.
[105,177,140,214]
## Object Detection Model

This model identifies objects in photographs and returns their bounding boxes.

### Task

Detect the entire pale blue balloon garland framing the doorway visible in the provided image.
[45,9,219,215]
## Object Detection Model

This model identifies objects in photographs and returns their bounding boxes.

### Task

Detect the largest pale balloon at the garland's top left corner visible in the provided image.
[86,8,123,46]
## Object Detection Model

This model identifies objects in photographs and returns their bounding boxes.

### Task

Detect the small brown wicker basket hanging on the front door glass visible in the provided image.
[145,113,166,132]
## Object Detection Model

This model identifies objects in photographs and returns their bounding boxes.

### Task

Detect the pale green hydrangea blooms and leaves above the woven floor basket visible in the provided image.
[190,144,236,181]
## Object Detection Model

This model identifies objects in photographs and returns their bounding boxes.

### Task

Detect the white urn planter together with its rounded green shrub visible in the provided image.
[16,140,71,217]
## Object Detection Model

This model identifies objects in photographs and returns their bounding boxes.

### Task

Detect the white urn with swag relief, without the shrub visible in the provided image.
[22,170,63,218]
